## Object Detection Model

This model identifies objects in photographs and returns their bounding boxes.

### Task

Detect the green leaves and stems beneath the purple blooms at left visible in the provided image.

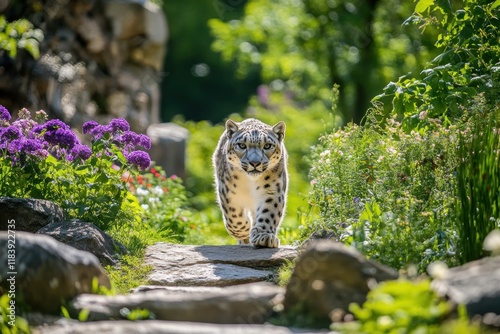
[0,109,143,229]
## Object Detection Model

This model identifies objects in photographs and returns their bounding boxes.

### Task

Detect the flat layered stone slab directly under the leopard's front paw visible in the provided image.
[145,242,297,286]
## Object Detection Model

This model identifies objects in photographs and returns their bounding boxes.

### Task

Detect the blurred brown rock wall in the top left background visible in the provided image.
[0,0,168,133]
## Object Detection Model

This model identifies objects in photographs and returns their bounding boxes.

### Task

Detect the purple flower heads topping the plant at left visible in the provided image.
[0,105,151,169]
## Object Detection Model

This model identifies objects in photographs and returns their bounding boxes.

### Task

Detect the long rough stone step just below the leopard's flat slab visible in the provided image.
[69,282,284,324]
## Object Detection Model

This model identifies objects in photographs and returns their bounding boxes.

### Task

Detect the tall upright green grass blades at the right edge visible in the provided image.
[457,107,500,263]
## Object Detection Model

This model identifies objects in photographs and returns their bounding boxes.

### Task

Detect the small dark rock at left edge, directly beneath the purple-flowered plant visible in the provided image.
[0,197,64,233]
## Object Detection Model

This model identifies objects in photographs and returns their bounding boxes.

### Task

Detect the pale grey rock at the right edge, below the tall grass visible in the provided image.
[432,256,500,317]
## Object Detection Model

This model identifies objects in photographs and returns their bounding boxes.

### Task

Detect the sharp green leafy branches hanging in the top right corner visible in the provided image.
[375,0,500,131]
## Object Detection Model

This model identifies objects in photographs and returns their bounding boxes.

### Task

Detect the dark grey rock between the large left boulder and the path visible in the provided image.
[36,220,127,266]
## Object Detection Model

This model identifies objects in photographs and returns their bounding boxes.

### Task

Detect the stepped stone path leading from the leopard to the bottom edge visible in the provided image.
[37,243,316,334]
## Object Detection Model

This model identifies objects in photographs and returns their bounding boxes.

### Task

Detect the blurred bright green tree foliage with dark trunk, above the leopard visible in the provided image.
[209,0,431,121]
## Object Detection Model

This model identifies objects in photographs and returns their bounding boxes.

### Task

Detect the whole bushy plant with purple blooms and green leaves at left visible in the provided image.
[0,106,151,229]
